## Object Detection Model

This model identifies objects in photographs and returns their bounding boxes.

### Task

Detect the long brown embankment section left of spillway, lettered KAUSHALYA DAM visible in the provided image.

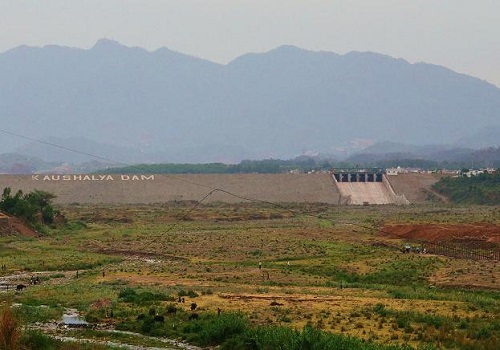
[0,174,340,204]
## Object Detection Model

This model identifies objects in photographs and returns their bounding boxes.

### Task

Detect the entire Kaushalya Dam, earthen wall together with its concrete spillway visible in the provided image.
[0,173,441,205]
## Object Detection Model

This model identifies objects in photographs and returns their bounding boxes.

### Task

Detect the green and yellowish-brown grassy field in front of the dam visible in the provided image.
[0,202,500,349]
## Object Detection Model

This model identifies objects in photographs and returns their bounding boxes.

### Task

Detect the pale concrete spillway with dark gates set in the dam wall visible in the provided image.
[333,174,410,205]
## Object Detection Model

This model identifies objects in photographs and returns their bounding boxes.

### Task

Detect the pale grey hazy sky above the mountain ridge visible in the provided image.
[0,0,500,86]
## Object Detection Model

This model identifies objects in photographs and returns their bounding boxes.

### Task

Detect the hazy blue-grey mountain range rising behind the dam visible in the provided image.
[0,39,500,163]
